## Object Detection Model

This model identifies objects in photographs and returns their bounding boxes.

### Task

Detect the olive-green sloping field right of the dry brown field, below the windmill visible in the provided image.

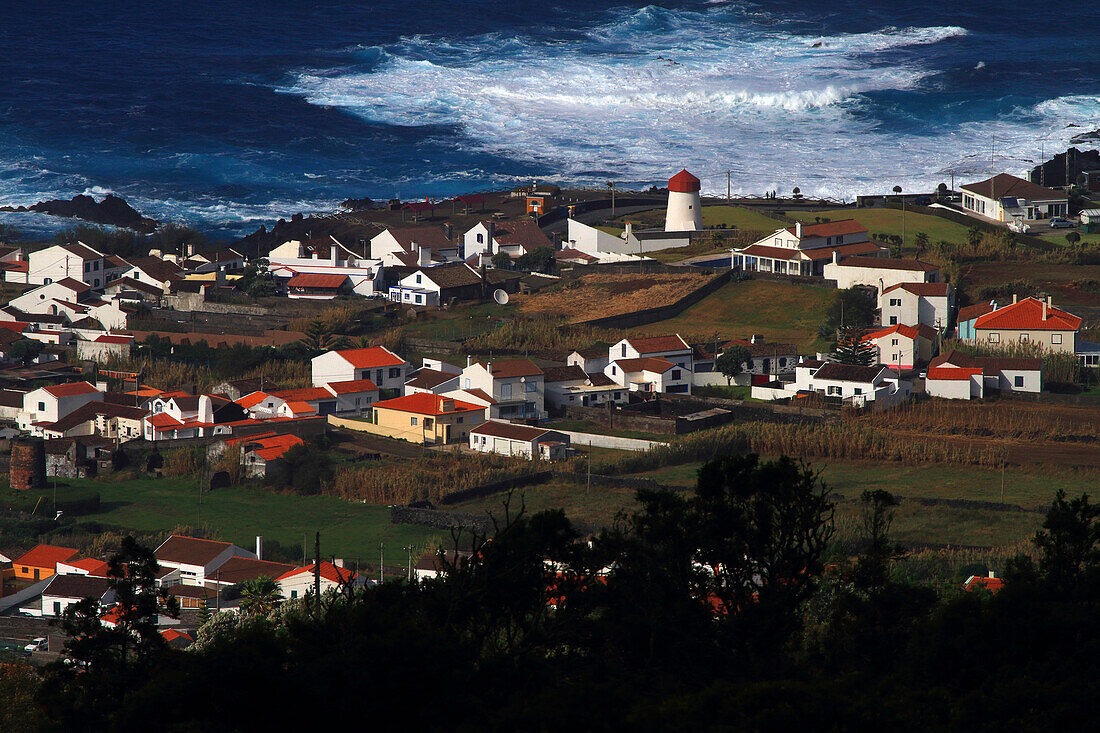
[633,281,836,352]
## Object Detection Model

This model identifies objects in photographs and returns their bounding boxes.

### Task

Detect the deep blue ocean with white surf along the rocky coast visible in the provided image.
[0,0,1100,233]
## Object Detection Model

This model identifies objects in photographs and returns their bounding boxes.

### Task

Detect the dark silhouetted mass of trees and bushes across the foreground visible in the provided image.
[0,456,1100,731]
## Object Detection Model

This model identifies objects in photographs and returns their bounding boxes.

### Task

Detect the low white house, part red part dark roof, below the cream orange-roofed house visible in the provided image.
[924,351,1043,400]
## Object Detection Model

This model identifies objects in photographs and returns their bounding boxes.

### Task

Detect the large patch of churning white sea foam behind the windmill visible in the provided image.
[281,7,985,200]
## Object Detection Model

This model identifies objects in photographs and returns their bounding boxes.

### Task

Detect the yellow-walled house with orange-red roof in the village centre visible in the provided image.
[371,392,485,445]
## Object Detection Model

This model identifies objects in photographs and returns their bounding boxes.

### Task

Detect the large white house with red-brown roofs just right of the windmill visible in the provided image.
[733,219,887,276]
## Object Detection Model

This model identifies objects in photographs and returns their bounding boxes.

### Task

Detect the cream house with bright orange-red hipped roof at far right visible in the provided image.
[974,297,1081,353]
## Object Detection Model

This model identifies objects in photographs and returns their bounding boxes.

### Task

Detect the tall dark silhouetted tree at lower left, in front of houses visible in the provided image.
[43,535,179,730]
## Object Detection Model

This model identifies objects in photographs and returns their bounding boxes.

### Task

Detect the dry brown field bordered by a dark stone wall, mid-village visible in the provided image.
[514,272,710,322]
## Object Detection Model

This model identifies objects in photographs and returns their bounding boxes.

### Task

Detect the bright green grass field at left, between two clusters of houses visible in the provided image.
[7,479,441,561]
